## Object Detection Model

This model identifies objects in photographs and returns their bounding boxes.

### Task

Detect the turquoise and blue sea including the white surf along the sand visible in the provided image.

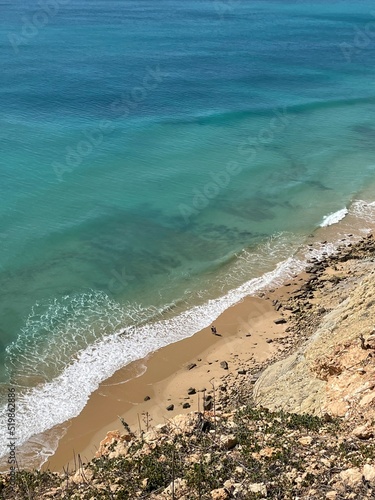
[0,0,375,468]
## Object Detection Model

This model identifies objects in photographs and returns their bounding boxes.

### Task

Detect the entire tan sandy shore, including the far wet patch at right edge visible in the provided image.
[43,200,375,470]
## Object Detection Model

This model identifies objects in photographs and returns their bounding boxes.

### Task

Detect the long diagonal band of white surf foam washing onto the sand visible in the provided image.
[0,259,304,466]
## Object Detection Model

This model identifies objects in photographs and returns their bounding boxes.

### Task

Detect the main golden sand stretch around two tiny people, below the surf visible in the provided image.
[44,274,306,470]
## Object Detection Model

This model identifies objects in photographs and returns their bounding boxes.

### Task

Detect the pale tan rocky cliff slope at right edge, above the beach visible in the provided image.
[254,238,375,423]
